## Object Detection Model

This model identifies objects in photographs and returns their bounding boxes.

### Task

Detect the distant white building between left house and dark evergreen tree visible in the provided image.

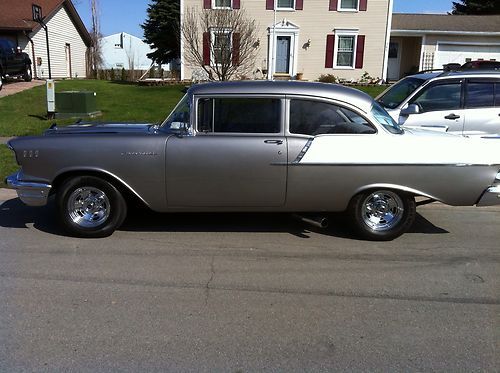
[101,32,169,71]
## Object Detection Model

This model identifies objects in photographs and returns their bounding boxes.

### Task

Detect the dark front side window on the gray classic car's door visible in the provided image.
[197,98,281,133]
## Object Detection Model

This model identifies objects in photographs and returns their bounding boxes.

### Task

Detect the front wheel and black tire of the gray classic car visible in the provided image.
[56,176,127,238]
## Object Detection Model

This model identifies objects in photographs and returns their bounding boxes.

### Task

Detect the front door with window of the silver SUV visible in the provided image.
[399,79,465,135]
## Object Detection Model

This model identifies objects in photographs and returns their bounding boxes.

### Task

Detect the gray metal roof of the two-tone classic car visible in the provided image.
[188,80,373,112]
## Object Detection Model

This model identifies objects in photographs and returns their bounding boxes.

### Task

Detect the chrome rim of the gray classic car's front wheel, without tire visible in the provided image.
[67,187,111,228]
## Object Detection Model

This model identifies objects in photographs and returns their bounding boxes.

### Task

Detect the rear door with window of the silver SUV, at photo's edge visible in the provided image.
[464,78,500,136]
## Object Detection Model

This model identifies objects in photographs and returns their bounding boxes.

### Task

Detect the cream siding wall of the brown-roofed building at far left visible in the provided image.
[19,6,87,78]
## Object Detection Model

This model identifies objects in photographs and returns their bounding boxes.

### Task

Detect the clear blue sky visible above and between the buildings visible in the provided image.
[73,0,458,38]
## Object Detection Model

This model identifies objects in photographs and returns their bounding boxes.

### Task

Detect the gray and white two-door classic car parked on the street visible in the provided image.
[7,81,500,240]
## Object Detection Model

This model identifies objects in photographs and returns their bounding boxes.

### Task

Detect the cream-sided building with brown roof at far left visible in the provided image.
[0,0,91,78]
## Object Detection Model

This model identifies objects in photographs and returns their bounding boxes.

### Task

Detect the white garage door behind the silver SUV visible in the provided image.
[434,43,500,69]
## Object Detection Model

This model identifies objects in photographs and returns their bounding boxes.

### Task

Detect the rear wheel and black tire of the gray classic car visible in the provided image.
[347,189,417,241]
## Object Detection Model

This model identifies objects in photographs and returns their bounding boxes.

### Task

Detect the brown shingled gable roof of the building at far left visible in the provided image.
[0,0,91,46]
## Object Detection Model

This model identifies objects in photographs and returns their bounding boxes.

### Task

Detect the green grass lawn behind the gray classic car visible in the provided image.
[0,80,385,187]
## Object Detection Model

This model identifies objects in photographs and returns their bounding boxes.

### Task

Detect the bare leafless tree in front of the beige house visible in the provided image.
[184,8,259,80]
